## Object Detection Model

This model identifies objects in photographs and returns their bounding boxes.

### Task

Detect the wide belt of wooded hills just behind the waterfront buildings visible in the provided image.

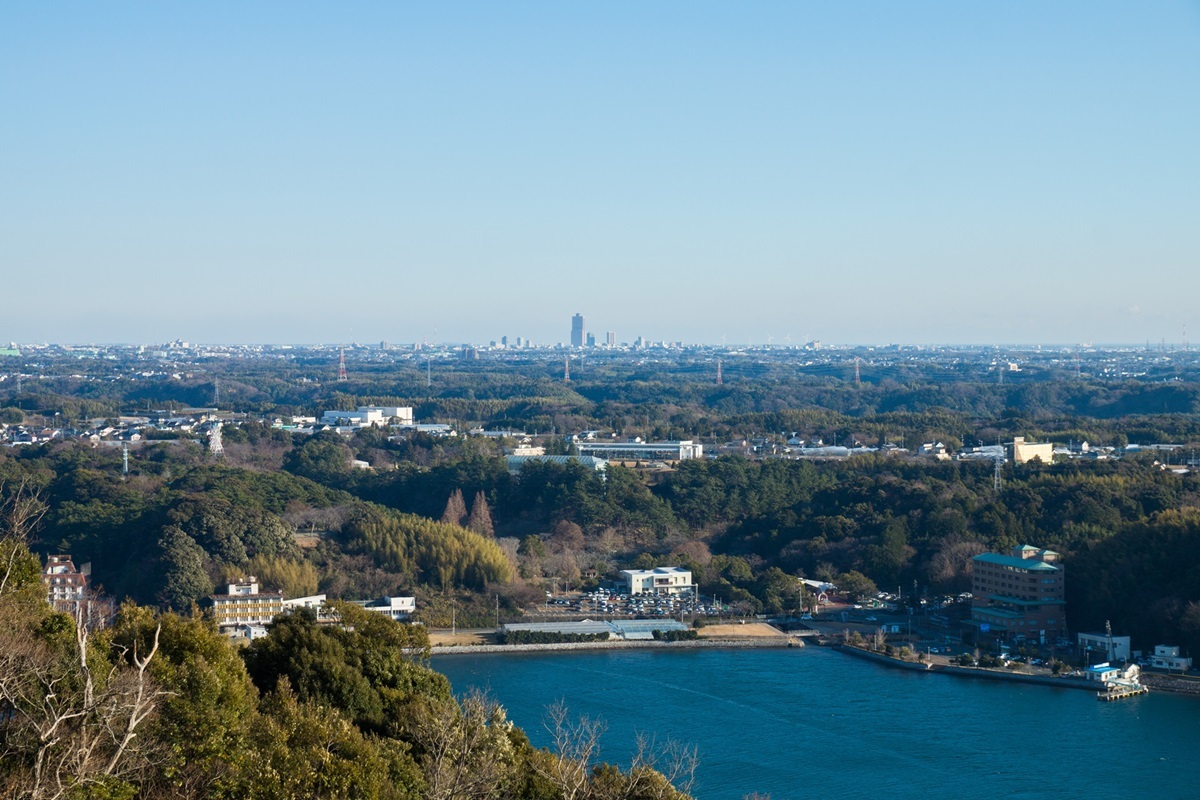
[0,433,1200,646]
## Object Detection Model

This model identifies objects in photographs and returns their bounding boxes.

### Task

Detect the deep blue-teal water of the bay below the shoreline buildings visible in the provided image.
[433,648,1200,800]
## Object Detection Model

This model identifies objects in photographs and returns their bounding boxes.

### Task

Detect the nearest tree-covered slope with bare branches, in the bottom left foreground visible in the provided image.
[0,534,685,800]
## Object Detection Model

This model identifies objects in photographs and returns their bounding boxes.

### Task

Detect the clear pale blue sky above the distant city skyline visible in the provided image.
[0,0,1200,343]
